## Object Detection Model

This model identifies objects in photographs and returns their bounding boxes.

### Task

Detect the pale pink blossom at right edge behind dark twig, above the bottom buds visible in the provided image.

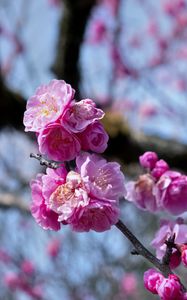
[151,218,187,259]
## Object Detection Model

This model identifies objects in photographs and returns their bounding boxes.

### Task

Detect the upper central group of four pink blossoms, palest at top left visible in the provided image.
[23,80,108,161]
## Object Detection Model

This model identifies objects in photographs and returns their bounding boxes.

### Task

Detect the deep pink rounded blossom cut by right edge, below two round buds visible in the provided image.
[156,171,187,215]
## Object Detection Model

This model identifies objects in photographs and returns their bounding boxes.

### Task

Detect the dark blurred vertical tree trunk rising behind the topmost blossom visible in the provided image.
[53,0,96,96]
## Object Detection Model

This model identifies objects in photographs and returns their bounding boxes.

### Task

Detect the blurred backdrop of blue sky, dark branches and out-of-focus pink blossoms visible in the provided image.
[0,0,187,300]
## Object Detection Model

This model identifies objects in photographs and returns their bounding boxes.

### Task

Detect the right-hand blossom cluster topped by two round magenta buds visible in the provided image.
[126,151,187,215]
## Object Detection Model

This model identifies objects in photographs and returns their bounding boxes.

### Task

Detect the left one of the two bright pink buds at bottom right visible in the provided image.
[144,269,164,294]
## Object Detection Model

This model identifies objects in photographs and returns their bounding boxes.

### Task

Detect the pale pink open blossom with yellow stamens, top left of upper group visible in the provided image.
[23,79,75,132]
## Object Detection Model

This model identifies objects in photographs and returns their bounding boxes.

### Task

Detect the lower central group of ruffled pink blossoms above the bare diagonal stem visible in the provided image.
[31,153,125,231]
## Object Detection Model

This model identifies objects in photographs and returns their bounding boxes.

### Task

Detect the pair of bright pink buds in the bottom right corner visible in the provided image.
[144,269,187,300]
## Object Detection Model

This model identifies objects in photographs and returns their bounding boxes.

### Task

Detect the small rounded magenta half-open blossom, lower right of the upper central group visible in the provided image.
[79,121,109,153]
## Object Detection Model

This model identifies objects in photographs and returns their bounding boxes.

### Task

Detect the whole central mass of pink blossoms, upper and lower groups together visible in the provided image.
[24,80,125,232]
